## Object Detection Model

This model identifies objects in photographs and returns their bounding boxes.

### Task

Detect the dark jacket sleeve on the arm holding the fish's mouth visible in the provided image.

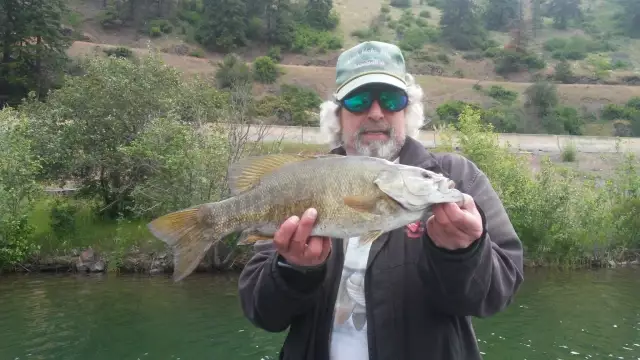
[420,155,523,317]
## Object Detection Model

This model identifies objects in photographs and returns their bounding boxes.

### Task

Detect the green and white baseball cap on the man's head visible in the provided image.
[335,41,407,101]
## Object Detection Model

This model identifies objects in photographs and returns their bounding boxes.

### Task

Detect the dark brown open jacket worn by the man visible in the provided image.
[239,138,523,360]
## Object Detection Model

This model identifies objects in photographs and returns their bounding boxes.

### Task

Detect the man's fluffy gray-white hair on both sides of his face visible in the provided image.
[320,74,424,148]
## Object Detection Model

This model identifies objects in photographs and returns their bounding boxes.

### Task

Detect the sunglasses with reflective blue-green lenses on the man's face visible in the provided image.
[340,88,409,113]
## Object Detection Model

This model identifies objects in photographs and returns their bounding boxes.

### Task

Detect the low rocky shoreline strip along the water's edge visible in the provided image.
[0,248,640,277]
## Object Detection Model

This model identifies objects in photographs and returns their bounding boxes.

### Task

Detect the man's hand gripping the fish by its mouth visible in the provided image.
[427,194,483,250]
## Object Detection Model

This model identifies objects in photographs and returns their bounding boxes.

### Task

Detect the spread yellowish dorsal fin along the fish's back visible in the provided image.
[228,154,341,195]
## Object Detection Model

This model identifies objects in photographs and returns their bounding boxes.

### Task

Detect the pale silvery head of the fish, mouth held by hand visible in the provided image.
[374,164,464,212]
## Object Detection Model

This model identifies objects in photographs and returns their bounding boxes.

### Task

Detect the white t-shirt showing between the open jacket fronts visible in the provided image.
[330,159,398,360]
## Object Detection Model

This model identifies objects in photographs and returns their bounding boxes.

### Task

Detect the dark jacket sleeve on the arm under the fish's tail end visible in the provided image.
[238,242,326,332]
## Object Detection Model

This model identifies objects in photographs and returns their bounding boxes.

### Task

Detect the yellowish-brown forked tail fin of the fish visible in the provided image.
[147,208,215,282]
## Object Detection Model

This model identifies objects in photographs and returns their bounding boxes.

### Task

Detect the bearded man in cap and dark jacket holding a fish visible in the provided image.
[239,42,523,360]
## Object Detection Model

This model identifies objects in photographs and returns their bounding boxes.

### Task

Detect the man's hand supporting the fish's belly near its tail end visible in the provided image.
[273,208,331,266]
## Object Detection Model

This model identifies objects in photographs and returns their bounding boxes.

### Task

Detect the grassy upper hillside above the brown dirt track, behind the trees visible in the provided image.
[69,0,640,85]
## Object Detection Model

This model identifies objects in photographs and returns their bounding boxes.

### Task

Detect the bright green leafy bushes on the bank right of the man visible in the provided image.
[444,108,640,266]
